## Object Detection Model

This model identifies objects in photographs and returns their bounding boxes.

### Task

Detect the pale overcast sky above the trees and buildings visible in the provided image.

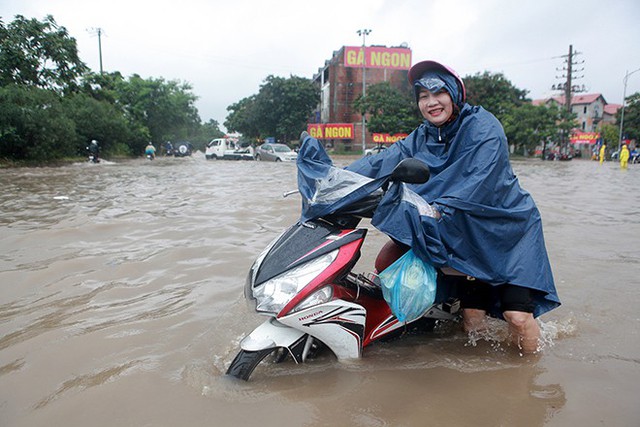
[0,0,640,129]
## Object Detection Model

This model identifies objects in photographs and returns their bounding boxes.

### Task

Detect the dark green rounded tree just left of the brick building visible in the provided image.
[224,75,320,143]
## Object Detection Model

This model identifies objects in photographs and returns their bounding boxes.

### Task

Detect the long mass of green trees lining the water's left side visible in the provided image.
[0,15,210,160]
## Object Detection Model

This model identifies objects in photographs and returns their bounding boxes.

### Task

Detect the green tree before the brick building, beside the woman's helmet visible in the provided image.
[354,82,422,133]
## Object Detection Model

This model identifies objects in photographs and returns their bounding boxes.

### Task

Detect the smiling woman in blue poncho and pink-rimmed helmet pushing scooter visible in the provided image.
[347,61,560,353]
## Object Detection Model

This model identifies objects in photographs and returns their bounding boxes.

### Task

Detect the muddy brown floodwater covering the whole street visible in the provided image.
[0,153,640,427]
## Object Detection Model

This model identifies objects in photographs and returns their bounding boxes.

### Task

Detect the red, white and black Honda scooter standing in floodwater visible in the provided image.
[226,159,460,381]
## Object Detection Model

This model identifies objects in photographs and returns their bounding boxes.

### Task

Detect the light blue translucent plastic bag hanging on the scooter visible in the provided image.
[378,250,437,322]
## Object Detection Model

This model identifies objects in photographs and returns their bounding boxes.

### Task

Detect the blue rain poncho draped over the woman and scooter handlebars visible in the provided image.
[298,104,560,317]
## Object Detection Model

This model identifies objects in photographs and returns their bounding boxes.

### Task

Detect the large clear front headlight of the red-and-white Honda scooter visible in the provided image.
[253,249,338,314]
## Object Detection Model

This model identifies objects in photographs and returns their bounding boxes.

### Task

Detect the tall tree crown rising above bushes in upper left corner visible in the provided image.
[0,15,88,92]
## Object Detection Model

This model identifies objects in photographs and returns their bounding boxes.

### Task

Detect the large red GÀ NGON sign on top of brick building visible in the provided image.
[344,46,411,70]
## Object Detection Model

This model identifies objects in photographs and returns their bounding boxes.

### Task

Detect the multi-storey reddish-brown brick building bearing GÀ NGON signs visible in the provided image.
[309,46,411,150]
